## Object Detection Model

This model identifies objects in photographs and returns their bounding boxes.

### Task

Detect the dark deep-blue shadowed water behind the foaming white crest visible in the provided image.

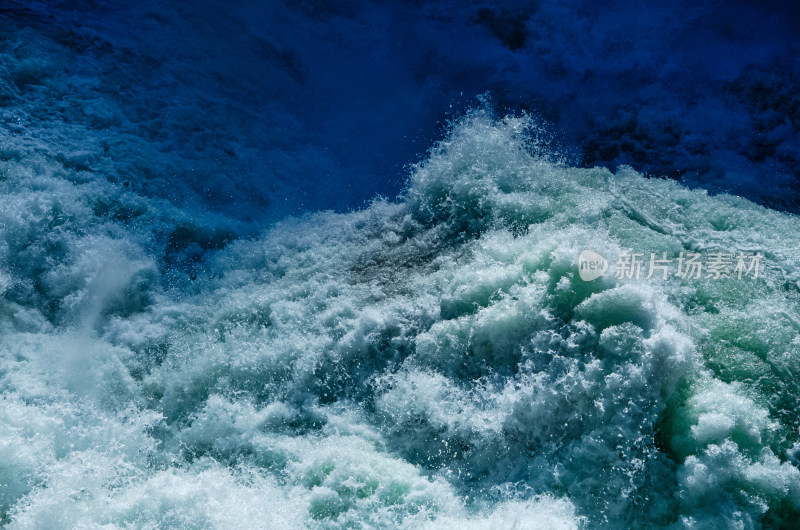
[2,0,800,219]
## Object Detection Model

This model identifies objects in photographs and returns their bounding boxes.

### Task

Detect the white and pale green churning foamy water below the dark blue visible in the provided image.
[0,106,800,529]
